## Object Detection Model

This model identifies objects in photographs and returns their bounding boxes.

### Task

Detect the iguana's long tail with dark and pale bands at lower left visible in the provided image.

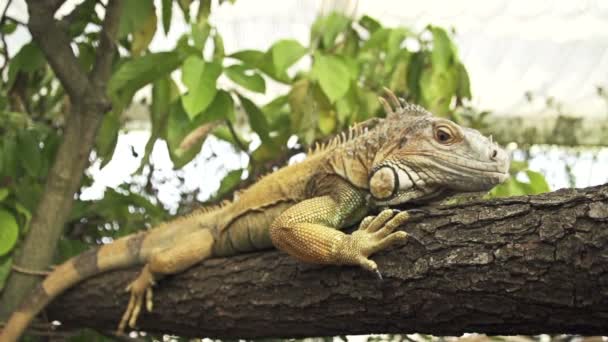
[0,214,204,342]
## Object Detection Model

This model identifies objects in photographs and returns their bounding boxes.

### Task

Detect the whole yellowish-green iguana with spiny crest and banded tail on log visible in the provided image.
[0,92,509,342]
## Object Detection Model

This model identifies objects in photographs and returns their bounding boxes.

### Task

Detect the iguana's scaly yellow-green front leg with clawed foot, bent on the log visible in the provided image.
[270,185,408,275]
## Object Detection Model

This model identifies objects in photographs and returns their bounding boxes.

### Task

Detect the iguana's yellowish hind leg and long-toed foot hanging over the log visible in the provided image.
[118,229,215,334]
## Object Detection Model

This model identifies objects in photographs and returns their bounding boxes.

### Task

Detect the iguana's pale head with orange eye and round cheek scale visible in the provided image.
[369,92,509,205]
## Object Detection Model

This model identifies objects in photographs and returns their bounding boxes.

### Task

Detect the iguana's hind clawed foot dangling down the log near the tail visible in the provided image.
[117,266,155,335]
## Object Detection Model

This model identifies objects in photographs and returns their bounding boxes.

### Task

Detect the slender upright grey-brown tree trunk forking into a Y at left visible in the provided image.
[0,0,122,320]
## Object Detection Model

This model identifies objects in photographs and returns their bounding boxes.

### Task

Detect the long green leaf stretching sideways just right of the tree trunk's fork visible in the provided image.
[108,51,182,105]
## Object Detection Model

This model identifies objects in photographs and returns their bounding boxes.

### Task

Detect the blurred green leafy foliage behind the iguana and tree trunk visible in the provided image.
[0,0,592,341]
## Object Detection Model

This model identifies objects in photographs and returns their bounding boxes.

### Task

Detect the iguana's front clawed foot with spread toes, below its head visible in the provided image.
[337,209,410,279]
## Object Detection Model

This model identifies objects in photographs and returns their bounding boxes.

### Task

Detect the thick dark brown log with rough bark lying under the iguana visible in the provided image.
[48,185,608,338]
